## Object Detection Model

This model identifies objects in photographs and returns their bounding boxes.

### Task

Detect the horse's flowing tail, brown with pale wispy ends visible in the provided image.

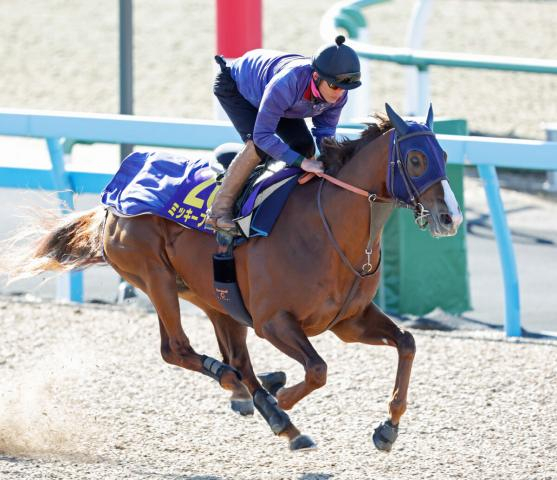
[0,207,105,282]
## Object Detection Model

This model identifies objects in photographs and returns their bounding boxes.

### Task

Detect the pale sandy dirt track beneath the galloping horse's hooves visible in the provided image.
[0,299,557,480]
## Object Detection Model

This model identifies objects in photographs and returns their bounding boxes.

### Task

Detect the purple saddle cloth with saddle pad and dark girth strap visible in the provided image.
[101,152,302,326]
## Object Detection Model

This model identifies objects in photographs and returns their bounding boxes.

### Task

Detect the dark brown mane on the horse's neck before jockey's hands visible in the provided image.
[319,113,393,175]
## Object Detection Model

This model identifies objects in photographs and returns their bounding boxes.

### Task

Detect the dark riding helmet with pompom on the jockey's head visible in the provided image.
[311,35,362,90]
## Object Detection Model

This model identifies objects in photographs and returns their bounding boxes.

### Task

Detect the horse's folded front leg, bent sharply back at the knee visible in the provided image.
[261,312,327,410]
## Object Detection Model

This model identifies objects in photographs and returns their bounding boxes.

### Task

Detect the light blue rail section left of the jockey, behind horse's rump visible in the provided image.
[0,109,240,302]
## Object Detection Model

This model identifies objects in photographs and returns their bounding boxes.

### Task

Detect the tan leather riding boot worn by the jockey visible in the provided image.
[207,140,261,232]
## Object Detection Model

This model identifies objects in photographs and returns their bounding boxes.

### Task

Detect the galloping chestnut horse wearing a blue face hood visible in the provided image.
[0,104,462,451]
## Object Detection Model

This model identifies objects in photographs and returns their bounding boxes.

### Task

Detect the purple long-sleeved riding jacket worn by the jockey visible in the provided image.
[230,49,347,165]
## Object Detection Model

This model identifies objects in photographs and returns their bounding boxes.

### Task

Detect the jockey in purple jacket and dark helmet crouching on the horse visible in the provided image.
[207,35,361,232]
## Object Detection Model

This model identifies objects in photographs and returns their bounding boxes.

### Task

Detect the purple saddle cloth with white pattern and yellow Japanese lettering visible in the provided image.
[101,152,301,238]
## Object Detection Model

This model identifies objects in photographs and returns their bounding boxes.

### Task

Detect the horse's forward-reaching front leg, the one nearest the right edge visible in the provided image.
[332,303,416,451]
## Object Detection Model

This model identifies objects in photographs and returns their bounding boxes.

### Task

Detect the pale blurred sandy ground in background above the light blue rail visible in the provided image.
[0,0,557,138]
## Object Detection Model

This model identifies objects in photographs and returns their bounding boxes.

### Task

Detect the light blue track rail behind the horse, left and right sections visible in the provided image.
[0,110,557,336]
